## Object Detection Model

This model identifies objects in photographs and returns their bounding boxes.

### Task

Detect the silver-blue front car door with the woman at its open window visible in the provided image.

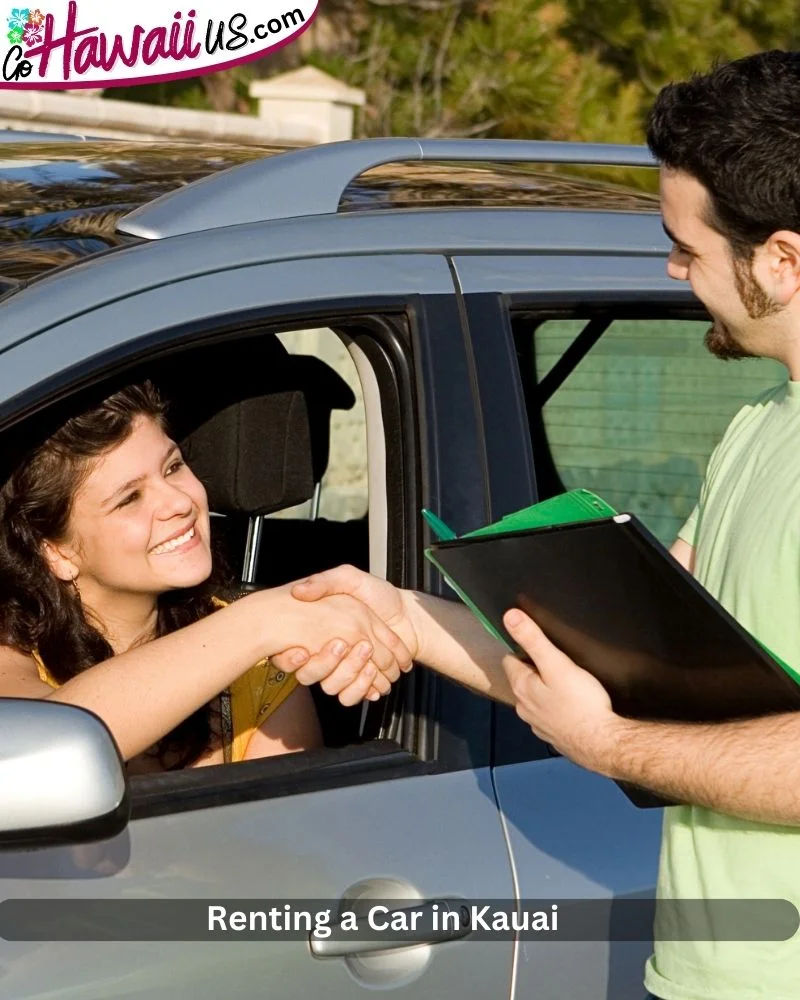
[0,248,513,1000]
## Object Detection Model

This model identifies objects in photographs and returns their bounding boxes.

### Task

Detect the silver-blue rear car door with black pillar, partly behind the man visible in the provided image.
[453,254,697,1000]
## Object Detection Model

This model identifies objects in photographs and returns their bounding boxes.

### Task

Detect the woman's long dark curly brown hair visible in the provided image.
[0,382,228,770]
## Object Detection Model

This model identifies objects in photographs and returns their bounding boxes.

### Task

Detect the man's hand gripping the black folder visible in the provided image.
[503,609,626,774]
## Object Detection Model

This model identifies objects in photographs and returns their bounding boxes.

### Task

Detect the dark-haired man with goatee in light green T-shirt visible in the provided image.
[276,51,800,1000]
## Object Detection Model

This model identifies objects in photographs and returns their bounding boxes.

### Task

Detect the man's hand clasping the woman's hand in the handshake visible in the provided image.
[272,566,419,705]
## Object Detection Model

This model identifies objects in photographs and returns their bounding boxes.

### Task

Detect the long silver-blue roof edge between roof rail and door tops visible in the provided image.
[0,209,665,352]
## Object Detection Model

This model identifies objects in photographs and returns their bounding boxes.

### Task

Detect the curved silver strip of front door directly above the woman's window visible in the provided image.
[0,248,453,419]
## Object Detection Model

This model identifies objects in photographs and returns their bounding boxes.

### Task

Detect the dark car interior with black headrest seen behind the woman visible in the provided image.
[151,334,385,747]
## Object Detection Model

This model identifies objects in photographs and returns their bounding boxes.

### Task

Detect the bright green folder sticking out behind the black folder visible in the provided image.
[422,490,800,684]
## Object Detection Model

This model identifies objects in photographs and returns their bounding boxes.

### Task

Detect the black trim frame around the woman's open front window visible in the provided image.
[0,257,489,818]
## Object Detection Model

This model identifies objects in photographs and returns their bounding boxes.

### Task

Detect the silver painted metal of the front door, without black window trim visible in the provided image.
[0,248,513,1000]
